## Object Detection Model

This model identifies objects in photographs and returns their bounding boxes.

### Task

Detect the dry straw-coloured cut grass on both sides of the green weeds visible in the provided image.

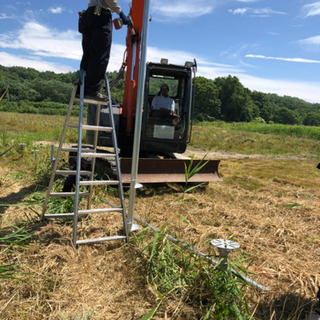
[0,141,320,320]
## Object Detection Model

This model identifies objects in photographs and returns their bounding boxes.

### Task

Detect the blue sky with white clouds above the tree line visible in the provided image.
[0,0,320,103]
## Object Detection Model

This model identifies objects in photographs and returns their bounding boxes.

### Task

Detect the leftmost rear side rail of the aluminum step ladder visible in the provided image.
[42,80,79,219]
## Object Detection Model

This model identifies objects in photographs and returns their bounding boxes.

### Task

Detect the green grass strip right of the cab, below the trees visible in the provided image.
[191,122,320,160]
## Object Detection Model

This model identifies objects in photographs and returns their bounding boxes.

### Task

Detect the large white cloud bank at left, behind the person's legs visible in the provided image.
[0,22,125,72]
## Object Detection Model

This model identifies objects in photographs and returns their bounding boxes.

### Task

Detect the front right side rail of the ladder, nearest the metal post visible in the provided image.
[105,74,129,241]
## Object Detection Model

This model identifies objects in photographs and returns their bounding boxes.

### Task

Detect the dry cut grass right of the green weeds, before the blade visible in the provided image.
[133,159,320,319]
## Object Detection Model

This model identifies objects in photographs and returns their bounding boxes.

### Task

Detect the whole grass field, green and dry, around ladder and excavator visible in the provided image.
[0,113,320,320]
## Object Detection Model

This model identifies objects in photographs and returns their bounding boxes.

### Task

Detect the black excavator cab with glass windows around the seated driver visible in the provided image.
[140,63,194,158]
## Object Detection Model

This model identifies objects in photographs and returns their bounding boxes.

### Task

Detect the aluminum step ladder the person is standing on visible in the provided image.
[42,70,129,247]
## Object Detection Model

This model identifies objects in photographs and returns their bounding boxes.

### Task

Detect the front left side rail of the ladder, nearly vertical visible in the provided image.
[72,71,86,247]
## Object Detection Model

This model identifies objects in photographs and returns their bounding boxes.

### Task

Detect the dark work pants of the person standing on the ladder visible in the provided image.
[80,7,112,93]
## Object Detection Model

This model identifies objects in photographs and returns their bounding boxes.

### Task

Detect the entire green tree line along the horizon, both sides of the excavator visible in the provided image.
[0,66,320,126]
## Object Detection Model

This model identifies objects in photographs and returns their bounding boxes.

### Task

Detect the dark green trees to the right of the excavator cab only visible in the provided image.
[194,76,320,126]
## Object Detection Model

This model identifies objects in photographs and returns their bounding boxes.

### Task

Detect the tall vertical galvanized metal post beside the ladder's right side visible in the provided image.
[128,0,150,231]
